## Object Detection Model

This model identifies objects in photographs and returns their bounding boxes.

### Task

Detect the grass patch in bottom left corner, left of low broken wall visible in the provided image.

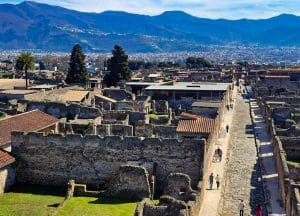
[0,185,65,216]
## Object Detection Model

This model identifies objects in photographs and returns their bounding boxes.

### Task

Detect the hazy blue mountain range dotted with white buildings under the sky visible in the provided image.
[0,1,300,52]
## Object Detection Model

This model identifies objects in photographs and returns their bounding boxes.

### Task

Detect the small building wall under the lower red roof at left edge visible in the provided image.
[0,164,15,194]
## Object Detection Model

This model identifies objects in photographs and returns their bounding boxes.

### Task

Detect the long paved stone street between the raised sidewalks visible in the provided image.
[219,90,266,216]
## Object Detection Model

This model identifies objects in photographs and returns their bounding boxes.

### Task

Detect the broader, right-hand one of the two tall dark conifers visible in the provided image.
[104,45,131,86]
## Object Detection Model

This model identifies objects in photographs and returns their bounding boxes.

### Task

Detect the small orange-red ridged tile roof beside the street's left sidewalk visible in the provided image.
[176,113,215,133]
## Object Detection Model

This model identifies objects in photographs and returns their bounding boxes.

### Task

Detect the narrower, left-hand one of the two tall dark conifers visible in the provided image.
[66,44,88,85]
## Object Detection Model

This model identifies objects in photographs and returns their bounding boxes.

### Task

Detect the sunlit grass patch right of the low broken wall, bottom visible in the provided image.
[57,197,137,216]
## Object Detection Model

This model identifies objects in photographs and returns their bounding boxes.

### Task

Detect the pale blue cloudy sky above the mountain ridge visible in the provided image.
[0,0,300,19]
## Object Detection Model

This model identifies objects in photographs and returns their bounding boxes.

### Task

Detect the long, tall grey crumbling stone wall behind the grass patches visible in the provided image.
[12,132,205,191]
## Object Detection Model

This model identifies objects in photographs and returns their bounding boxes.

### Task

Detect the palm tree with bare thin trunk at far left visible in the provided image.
[16,52,35,89]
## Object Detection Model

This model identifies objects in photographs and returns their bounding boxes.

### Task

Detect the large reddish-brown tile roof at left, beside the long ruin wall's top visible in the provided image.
[0,110,59,146]
